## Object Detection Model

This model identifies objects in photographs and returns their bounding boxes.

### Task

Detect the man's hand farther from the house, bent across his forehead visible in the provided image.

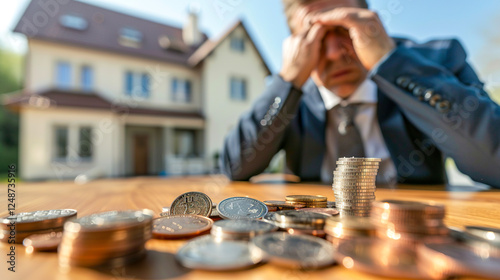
[312,8,395,70]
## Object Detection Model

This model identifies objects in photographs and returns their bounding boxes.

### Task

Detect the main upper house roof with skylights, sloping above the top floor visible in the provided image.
[14,0,207,66]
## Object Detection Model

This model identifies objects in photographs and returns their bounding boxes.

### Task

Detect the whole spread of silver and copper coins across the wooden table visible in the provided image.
[1,164,500,279]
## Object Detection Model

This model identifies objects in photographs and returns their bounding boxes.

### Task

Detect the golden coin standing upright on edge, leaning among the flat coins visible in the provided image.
[170,192,212,217]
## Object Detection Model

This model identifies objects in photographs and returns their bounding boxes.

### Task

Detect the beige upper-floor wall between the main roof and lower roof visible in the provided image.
[25,39,202,111]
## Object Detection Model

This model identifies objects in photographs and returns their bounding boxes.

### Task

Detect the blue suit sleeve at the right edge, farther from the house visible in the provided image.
[371,40,500,188]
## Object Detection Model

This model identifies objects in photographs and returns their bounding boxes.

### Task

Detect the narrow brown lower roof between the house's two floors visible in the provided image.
[3,89,204,119]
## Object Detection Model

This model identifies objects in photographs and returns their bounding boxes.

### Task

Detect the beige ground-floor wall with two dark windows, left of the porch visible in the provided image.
[19,108,124,179]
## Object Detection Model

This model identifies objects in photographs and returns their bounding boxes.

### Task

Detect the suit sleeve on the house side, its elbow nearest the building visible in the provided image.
[220,76,302,180]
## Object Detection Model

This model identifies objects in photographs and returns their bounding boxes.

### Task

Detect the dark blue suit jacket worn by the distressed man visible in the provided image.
[221,39,500,187]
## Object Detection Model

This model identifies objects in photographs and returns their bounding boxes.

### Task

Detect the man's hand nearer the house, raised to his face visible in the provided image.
[280,23,327,88]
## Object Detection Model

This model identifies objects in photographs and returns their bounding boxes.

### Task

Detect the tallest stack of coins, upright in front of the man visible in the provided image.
[333,157,381,217]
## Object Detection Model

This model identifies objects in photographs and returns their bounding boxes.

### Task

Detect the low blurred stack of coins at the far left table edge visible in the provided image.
[0,209,76,243]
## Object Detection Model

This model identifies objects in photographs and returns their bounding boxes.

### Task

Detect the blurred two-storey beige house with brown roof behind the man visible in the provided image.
[4,0,271,180]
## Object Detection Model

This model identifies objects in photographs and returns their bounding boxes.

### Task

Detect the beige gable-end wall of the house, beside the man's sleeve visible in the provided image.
[203,26,267,164]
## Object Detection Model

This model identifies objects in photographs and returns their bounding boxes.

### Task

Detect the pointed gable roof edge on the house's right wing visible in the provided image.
[188,20,271,75]
